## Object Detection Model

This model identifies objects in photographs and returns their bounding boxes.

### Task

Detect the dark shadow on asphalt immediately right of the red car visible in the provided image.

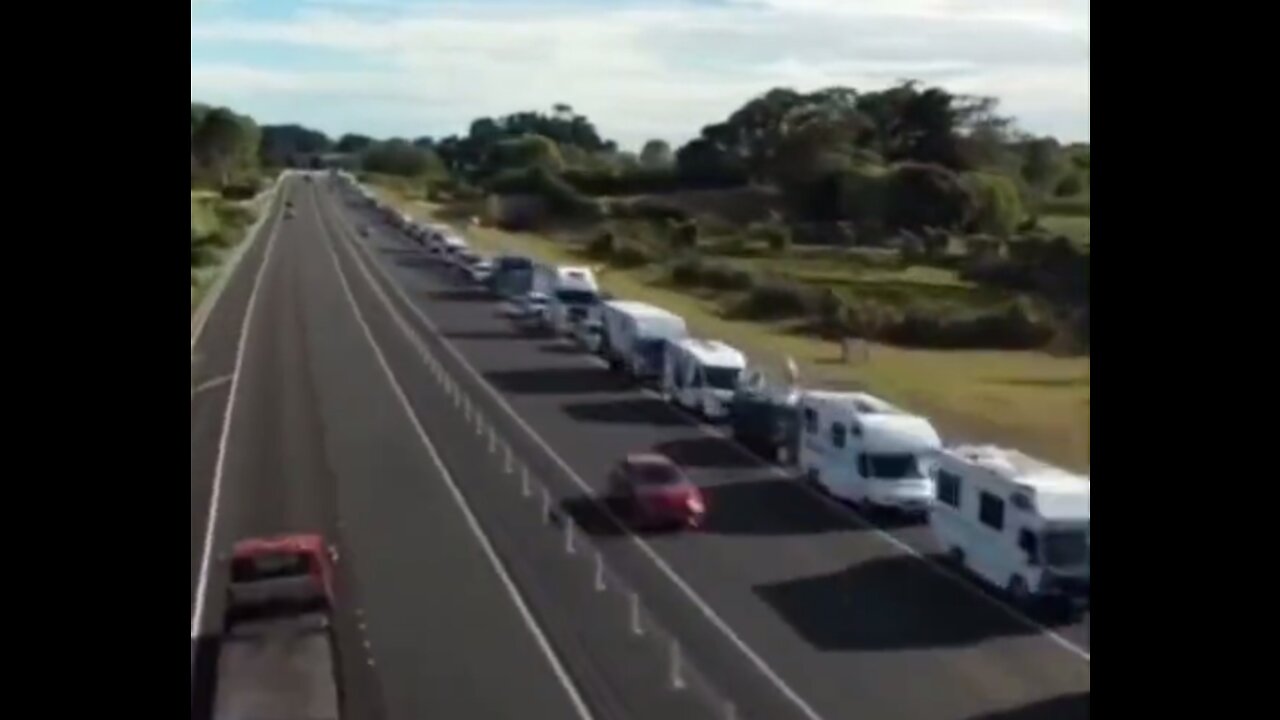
[701,478,858,536]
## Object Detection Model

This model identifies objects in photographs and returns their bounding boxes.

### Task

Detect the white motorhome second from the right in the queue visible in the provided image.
[797,391,942,512]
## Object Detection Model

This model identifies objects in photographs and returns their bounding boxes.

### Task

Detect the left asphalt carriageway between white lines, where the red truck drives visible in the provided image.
[192,181,599,720]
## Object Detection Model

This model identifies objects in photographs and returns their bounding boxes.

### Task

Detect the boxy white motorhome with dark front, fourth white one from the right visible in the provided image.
[600,300,689,379]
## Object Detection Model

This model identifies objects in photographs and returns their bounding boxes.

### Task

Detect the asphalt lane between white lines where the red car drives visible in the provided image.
[330,185,1089,717]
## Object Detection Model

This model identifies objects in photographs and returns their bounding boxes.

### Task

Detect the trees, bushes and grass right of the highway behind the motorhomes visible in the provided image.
[194,82,1091,469]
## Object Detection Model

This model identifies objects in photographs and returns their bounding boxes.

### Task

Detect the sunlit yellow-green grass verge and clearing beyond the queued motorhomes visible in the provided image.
[380,183,1089,470]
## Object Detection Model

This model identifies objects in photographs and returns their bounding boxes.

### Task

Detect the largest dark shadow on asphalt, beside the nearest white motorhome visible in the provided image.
[747,556,1038,651]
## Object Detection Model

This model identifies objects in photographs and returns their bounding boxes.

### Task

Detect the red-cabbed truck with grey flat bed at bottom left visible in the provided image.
[211,534,343,720]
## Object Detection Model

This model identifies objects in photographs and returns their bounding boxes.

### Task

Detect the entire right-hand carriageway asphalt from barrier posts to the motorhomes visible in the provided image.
[334,179,1091,720]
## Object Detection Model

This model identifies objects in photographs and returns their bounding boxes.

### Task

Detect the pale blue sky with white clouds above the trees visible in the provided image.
[191,0,1089,149]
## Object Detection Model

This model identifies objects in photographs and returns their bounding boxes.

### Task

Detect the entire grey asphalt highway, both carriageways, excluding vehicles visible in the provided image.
[191,178,1089,720]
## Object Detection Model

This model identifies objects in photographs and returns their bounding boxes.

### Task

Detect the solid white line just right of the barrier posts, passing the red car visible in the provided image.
[327,194,823,720]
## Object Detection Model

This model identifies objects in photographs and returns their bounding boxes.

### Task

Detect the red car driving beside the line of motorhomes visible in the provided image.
[609,452,707,528]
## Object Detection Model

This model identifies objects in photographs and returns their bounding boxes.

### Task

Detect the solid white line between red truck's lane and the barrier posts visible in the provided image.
[317,207,593,720]
